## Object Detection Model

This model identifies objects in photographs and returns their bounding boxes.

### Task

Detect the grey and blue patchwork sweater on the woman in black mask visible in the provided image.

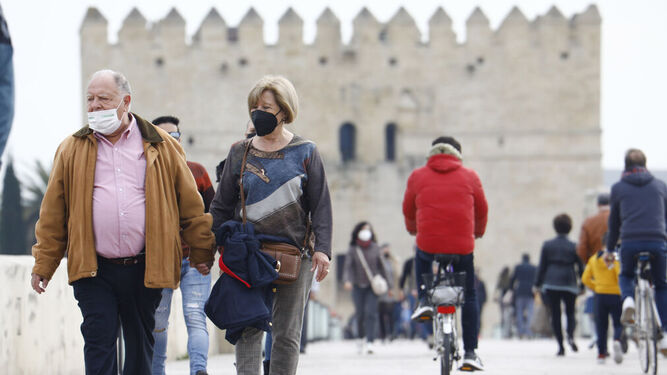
[210,135,333,258]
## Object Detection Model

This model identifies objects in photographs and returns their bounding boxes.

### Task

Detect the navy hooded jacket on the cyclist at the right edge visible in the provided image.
[607,168,667,251]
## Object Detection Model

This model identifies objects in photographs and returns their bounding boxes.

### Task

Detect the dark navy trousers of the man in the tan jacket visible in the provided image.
[72,257,162,375]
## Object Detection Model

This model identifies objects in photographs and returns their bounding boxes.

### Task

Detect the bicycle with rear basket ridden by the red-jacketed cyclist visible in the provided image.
[424,254,473,375]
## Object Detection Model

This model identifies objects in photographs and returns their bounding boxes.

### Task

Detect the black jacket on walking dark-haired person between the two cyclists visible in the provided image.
[535,235,584,293]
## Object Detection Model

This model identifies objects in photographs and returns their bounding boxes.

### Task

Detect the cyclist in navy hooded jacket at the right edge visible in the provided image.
[607,149,667,355]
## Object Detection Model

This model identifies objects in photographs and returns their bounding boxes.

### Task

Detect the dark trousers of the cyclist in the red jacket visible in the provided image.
[415,249,479,352]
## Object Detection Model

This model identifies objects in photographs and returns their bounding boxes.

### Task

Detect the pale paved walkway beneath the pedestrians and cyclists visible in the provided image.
[167,339,656,375]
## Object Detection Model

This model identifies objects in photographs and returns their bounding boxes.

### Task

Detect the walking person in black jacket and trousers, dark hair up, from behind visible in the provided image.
[535,214,584,356]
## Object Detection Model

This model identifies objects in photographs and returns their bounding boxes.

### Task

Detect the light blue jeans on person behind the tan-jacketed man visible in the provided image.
[153,259,211,375]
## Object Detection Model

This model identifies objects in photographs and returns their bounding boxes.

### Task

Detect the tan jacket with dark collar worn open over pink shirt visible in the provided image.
[32,114,215,288]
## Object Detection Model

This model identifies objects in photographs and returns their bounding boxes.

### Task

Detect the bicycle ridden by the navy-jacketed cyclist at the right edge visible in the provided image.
[631,252,662,375]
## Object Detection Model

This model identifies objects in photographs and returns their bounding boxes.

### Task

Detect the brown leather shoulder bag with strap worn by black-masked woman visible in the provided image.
[239,140,310,284]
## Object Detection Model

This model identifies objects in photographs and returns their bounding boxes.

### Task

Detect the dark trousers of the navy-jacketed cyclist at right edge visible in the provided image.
[618,241,667,331]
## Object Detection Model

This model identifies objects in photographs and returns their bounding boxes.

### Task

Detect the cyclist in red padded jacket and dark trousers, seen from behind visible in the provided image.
[403,137,487,370]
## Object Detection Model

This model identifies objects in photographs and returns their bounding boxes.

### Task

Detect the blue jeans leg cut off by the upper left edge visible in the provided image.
[0,43,14,160]
